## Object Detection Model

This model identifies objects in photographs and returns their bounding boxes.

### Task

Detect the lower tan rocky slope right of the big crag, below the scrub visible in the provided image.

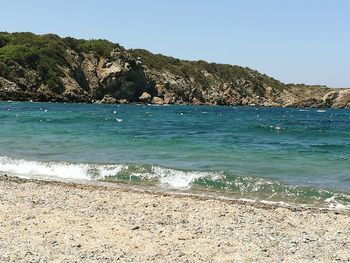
[142,64,350,108]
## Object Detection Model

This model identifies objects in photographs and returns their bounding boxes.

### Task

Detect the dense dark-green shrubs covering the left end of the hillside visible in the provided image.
[0,32,119,89]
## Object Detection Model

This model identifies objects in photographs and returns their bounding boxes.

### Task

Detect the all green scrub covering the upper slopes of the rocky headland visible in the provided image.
[0,32,285,93]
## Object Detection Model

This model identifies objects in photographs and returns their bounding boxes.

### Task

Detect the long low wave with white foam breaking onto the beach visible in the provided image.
[0,156,350,209]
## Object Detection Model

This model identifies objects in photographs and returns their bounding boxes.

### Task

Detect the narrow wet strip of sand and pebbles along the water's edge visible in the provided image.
[0,174,350,213]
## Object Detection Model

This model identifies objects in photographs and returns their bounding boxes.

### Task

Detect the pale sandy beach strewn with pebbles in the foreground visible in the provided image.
[0,176,350,262]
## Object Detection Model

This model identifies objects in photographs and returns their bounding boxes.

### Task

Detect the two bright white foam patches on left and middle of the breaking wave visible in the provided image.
[0,157,219,189]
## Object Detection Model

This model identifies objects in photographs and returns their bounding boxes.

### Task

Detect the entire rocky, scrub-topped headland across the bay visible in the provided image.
[0,33,350,108]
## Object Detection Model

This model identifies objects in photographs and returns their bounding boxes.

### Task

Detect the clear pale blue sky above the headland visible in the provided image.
[0,0,350,87]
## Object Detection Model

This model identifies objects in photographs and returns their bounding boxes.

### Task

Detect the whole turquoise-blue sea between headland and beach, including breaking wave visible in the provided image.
[0,102,350,208]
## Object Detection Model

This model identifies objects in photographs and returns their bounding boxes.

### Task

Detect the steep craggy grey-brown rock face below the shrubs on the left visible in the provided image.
[0,42,154,103]
